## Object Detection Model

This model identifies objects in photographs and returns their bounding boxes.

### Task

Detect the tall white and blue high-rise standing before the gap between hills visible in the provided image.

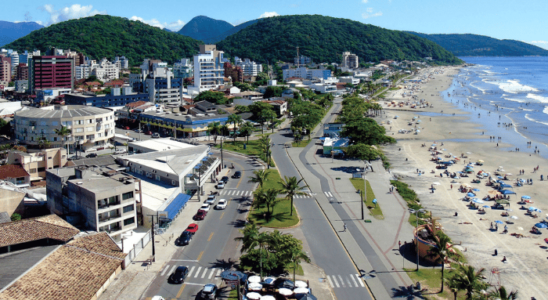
[188,45,224,95]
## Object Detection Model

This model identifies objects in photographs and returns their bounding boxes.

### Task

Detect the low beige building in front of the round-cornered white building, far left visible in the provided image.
[7,148,67,182]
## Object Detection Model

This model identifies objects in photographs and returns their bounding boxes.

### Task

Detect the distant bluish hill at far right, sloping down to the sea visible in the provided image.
[410,32,548,56]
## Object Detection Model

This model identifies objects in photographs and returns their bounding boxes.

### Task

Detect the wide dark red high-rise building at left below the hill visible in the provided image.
[29,56,74,94]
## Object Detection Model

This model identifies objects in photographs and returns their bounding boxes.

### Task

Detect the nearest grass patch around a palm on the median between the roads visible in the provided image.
[249,199,299,228]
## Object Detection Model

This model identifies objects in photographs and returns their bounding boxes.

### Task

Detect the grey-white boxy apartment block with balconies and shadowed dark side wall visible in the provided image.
[46,164,142,241]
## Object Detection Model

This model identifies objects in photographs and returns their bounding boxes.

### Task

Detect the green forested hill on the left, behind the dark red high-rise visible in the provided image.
[4,15,203,65]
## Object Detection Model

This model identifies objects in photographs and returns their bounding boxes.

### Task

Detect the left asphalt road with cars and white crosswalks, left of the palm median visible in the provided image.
[141,152,261,299]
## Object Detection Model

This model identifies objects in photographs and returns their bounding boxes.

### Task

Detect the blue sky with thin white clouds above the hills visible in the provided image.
[0,0,548,49]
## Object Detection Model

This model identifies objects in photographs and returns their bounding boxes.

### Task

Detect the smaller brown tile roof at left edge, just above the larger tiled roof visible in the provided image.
[0,215,80,247]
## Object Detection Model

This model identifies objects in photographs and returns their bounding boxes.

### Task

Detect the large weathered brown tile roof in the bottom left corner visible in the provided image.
[0,232,126,300]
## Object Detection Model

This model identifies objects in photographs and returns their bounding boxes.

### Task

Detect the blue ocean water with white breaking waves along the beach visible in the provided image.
[442,57,548,157]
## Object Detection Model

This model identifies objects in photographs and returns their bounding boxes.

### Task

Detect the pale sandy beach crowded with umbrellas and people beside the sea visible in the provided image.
[381,67,548,299]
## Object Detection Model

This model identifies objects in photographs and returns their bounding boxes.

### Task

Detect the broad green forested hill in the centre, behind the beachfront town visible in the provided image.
[217,15,461,64]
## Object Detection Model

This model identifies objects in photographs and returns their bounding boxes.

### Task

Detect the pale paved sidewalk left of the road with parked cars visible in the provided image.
[99,169,230,300]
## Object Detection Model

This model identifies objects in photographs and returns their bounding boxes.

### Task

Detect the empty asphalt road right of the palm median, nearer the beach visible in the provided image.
[271,101,372,300]
